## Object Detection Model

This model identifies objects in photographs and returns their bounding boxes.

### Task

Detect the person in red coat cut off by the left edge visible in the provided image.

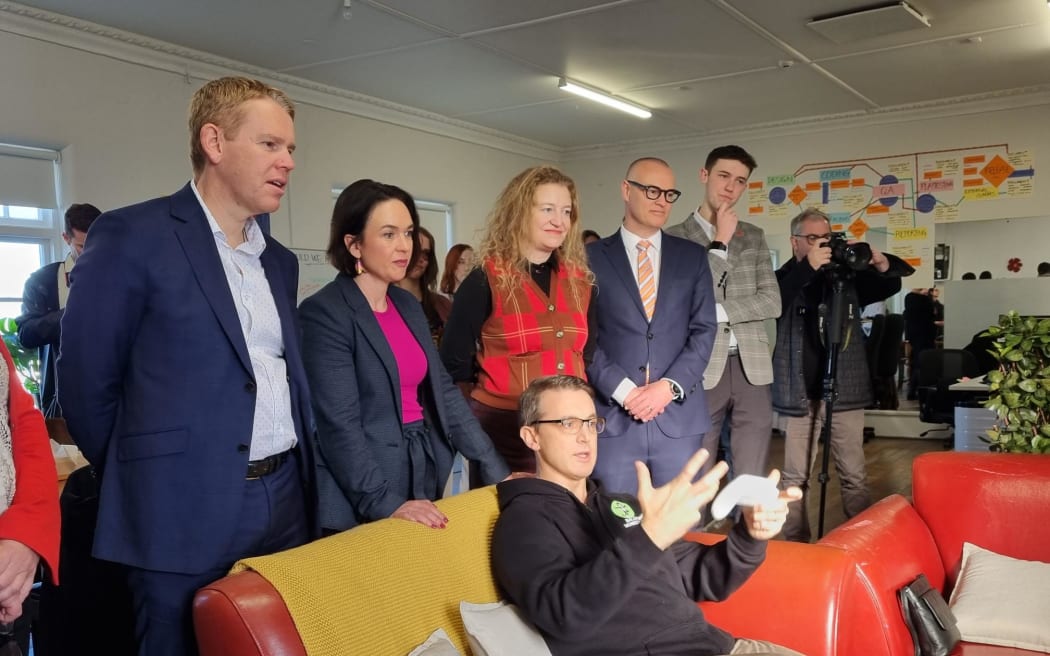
[0,340,61,654]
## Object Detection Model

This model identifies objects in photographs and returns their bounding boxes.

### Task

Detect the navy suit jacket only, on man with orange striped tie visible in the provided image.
[587,230,717,438]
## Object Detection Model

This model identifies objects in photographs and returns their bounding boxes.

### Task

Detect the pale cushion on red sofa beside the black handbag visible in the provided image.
[948,543,1050,652]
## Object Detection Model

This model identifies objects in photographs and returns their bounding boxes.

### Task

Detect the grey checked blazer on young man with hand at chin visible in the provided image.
[667,214,780,389]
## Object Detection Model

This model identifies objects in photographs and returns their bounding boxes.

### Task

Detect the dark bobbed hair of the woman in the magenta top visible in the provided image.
[328,178,417,277]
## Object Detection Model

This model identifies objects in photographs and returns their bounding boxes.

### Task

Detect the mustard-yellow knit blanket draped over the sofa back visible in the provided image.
[231,486,499,656]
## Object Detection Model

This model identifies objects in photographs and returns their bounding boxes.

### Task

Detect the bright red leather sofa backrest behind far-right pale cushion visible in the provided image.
[911,452,1050,587]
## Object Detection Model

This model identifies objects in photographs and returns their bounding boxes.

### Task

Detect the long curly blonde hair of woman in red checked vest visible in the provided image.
[478,165,594,292]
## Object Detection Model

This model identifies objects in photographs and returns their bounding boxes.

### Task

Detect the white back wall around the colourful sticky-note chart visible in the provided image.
[564,99,1050,275]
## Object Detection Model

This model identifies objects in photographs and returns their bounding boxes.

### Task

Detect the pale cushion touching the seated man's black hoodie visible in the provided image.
[460,601,550,656]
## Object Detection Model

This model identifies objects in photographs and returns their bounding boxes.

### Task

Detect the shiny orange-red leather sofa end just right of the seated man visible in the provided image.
[687,533,860,656]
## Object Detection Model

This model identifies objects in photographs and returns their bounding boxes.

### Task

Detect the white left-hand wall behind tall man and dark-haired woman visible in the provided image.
[0,27,538,248]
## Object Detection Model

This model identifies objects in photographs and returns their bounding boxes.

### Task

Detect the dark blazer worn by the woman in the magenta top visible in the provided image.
[299,273,509,530]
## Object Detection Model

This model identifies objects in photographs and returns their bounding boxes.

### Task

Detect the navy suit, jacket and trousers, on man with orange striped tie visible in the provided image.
[587,230,717,492]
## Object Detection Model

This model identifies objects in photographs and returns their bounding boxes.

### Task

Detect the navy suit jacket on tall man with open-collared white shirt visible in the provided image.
[59,184,316,573]
